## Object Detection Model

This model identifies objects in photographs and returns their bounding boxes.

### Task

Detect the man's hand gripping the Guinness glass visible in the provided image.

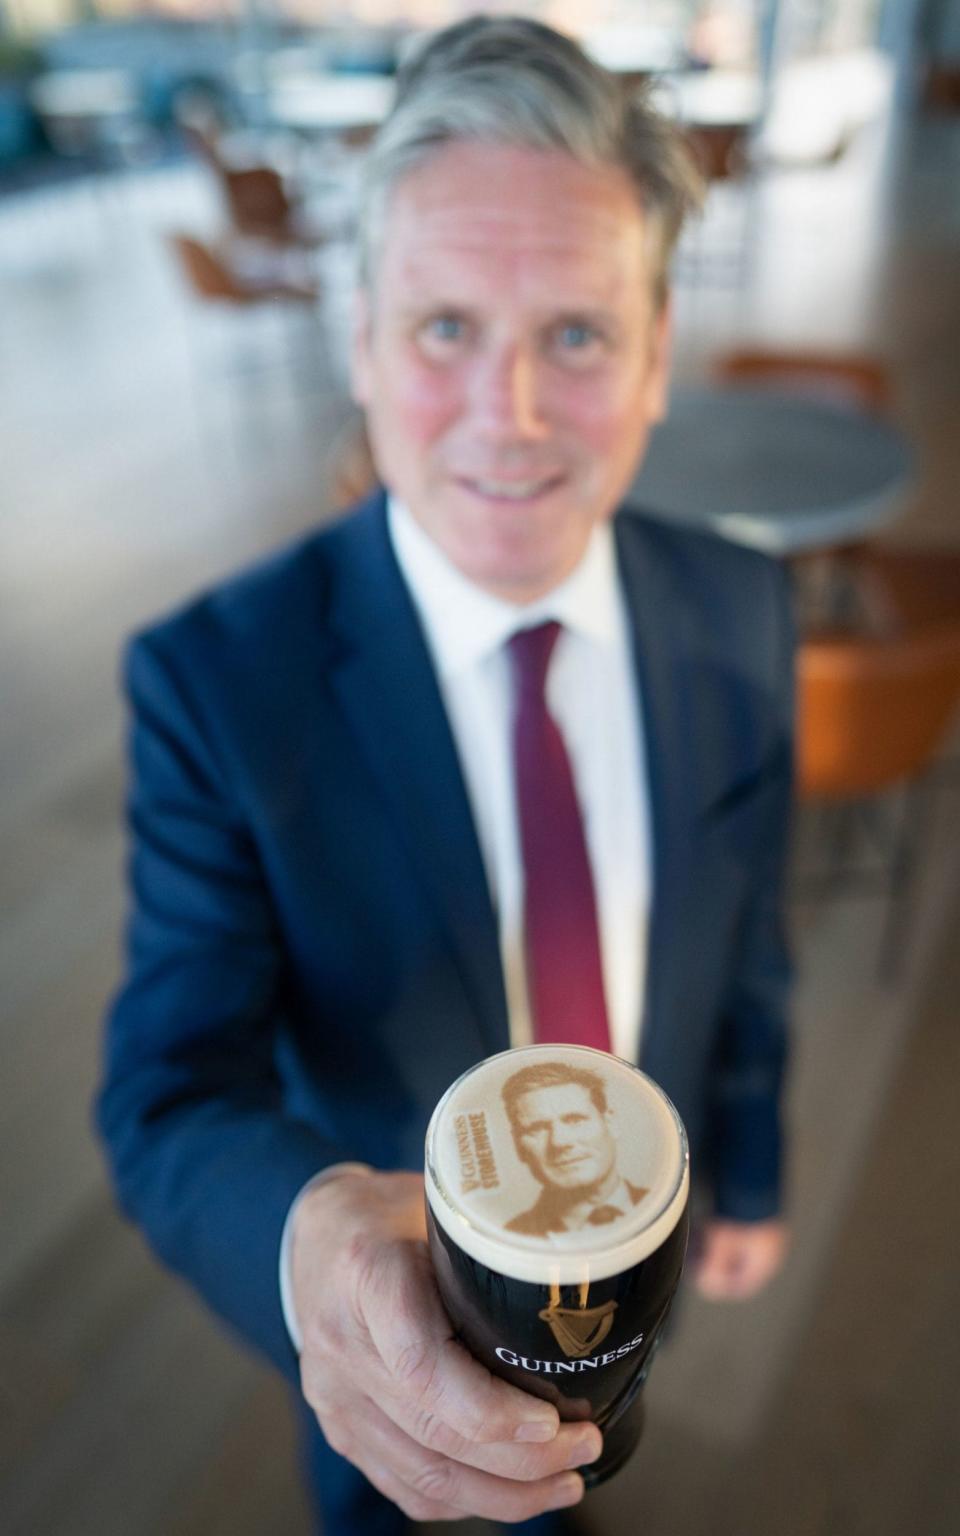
[292,1174,602,1521]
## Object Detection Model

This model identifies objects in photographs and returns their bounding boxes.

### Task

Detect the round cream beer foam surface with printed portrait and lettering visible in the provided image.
[441,1046,673,1249]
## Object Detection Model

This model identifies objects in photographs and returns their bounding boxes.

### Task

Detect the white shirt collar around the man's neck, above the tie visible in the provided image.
[387,496,621,677]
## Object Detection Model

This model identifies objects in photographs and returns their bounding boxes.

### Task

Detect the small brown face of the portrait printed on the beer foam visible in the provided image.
[513,1083,616,1192]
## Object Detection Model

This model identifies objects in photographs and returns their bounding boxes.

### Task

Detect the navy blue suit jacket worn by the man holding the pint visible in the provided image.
[98,495,793,1376]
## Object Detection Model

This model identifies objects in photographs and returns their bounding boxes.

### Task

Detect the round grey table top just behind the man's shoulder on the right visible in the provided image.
[627,386,912,554]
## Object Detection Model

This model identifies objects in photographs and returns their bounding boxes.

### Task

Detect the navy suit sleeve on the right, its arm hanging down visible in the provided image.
[708,564,794,1221]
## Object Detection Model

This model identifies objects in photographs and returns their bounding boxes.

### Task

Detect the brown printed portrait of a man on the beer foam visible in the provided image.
[502,1061,647,1236]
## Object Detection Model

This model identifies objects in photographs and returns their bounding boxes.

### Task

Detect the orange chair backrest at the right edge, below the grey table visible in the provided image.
[797,624,960,800]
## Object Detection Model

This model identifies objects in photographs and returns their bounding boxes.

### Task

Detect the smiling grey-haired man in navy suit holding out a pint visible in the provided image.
[100,20,791,1536]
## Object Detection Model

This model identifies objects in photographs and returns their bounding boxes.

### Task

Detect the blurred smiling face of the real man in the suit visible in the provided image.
[353,143,668,602]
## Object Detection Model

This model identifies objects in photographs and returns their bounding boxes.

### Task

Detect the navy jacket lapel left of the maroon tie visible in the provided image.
[317,495,508,1054]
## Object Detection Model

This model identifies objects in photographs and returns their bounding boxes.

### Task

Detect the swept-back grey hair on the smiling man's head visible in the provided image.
[359,15,703,303]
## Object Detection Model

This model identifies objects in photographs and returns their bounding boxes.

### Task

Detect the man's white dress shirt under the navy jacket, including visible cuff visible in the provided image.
[280,499,653,1347]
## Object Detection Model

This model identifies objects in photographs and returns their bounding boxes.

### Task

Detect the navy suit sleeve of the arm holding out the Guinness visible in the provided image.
[97,637,343,1378]
